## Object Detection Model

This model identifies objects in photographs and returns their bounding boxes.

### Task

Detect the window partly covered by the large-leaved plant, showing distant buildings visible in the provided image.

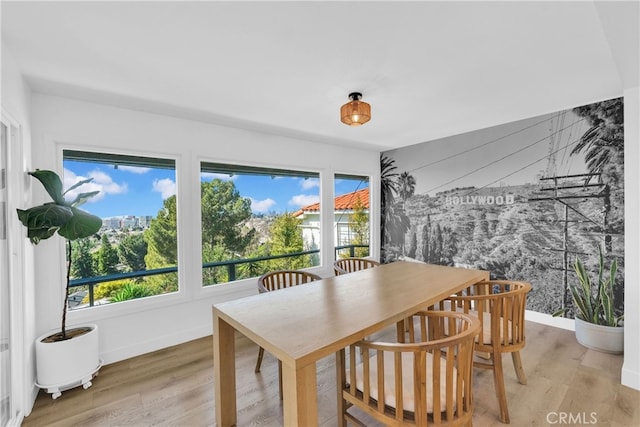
[63,150,179,309]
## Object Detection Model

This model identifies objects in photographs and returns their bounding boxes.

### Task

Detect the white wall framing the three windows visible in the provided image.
[32,94,379,363]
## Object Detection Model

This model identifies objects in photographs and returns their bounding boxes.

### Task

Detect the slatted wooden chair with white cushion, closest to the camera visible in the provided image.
[336,310,480,427]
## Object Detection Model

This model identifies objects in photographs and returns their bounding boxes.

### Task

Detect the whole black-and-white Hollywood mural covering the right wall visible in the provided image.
[380,98,624,317]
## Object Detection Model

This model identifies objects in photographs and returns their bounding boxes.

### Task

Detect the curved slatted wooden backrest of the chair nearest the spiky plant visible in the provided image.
[448,280,531,353]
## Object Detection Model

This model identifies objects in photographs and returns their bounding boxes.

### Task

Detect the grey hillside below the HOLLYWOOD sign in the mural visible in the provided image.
[398,184,624,313]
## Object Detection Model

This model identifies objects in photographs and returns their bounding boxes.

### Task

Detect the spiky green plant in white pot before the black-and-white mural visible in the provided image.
[554,246,624,354]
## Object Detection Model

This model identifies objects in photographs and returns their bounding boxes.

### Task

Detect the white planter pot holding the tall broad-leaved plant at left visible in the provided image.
[36,325,101,399]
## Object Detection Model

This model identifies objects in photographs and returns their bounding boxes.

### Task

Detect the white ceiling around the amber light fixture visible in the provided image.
[1,0,639,150]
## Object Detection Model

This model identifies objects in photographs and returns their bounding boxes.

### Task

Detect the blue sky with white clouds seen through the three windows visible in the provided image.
[64,161,366,218]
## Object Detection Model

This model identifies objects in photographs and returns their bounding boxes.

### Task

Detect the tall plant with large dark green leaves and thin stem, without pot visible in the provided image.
[17,169,102,340]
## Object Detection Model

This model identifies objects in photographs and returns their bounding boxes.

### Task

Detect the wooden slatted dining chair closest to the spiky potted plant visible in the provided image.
[440,280,531,424]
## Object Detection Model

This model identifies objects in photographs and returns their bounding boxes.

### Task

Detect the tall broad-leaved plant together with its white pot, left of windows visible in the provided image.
[17,170,102,399]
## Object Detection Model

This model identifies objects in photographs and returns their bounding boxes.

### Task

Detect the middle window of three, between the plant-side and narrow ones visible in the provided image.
[200,162,320,286]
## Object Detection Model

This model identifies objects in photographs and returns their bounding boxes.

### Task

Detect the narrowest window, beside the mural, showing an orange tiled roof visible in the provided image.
[334,174,370,258]
